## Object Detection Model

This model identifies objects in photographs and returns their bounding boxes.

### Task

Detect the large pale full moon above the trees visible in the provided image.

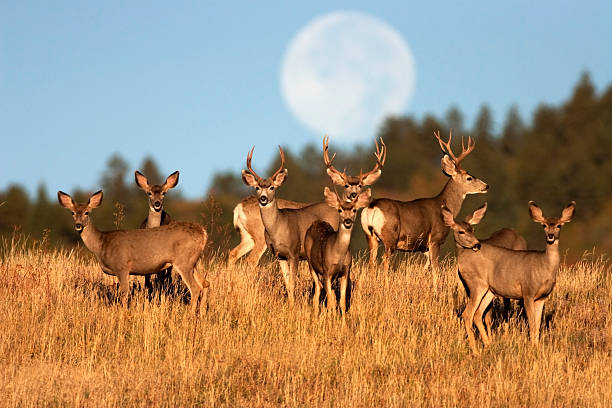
[281,11,415,141]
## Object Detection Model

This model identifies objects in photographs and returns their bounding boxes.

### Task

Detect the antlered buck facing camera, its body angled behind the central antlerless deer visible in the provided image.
[242,146,338,303]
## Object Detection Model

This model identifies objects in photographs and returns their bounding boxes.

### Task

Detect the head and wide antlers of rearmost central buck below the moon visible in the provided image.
[323,135,387,201]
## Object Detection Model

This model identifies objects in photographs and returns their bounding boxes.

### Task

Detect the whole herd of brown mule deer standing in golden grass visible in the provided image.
[58,130,575,354]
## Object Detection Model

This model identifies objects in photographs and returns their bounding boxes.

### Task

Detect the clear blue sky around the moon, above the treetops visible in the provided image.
[0,0,612,197]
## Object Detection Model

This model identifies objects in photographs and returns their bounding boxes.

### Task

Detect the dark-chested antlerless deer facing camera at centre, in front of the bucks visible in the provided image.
[304,187,372,321]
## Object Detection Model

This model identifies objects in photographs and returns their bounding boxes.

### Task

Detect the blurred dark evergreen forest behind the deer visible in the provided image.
[0,73,612,259]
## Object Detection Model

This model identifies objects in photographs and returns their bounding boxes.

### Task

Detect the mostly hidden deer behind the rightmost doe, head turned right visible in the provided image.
[442,203,527,337]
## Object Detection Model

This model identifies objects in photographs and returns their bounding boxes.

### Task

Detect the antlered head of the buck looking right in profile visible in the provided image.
[434,129,489,195]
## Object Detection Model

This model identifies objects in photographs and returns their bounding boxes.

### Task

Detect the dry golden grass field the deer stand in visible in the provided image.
[0,236,612,407]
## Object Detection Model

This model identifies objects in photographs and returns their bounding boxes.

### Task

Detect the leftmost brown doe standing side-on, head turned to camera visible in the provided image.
[57,190,210,312]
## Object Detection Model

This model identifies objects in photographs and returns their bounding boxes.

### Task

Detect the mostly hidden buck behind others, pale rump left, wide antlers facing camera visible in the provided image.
[228,135,386,266]
